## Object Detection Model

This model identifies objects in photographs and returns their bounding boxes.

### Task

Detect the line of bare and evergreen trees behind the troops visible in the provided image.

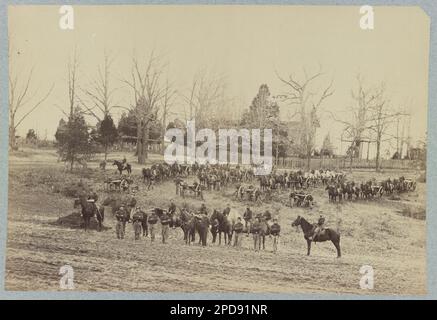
[9,44,416,170]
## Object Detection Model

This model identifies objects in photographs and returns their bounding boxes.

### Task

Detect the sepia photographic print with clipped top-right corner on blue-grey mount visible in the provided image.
[3,5,430,296]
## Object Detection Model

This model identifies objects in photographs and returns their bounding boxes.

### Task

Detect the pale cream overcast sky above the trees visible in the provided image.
[8,5,429,156]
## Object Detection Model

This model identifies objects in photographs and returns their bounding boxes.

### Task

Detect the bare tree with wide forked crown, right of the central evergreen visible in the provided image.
[277,68,334,169]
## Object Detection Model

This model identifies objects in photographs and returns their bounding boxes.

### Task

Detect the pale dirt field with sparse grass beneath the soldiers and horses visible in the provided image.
[6,150,426,295]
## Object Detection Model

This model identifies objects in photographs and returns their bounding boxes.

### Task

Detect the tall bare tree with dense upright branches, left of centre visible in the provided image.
[124,52,165,164]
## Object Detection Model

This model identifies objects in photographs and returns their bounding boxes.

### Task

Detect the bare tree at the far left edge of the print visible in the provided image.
[9,42,54,149]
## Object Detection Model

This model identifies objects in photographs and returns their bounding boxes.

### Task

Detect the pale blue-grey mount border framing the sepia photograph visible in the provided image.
[0,0,437,300]
